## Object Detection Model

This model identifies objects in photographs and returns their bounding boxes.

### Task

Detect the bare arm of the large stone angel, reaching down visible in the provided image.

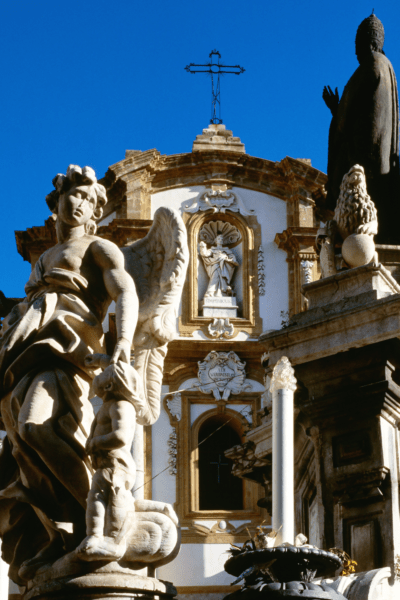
[93,240,139,363]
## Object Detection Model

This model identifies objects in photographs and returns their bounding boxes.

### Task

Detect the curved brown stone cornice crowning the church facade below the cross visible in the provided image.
[16,149,327,265]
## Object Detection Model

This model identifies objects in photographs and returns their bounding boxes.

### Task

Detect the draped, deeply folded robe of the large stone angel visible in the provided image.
[0,259,106,581]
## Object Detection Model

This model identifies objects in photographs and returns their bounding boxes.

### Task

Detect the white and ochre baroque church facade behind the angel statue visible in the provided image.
[7,124,326,600]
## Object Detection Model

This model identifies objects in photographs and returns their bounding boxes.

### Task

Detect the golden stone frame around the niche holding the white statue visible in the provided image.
[179,211,262,338]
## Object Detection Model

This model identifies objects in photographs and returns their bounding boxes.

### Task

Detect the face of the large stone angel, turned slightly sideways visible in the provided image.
[57,185,96,227]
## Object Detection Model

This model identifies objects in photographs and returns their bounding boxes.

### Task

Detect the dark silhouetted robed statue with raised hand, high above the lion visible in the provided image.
[322,14,400,244]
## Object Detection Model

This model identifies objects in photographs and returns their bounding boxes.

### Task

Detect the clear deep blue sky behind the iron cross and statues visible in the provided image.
[0,0,400,296]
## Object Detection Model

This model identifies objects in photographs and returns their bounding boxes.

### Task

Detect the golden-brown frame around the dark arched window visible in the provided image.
[174,390,262,540]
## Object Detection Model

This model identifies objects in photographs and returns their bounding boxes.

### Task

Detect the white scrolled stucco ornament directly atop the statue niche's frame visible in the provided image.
[183,185,255,217]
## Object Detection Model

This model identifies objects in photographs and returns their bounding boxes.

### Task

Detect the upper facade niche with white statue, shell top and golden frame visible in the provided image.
[180,210,262,341]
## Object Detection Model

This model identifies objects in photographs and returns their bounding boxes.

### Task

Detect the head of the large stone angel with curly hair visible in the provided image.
[46,165,107,235]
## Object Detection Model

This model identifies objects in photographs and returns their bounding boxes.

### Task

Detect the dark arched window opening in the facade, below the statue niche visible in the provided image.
[198,415,244,510]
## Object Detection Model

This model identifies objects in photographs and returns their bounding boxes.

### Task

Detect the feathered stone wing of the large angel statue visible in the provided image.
[122,207,189,425]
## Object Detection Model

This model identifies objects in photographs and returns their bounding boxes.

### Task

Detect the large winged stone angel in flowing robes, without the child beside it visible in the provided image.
[0,165,188,585]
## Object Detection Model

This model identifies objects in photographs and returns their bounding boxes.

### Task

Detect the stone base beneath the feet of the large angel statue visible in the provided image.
[24,557,177,600]
